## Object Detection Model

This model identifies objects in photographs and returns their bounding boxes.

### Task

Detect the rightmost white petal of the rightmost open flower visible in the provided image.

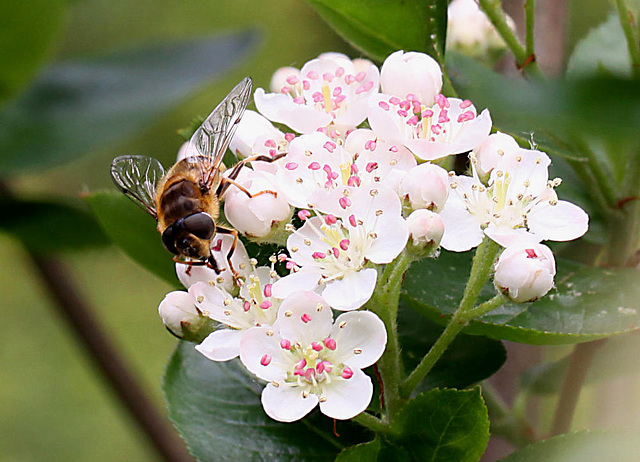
[527,201,589,241]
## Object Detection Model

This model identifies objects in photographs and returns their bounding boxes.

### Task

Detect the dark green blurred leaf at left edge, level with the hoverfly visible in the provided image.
[0,195,109,253]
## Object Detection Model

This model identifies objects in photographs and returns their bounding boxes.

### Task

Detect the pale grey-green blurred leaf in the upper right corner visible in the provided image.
[567,12,631,77]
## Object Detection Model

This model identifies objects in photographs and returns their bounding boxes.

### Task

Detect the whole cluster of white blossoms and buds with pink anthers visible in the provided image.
[160,51,588,422]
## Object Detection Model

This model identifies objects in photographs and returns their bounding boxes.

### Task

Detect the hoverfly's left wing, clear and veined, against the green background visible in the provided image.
[111,156,164,219]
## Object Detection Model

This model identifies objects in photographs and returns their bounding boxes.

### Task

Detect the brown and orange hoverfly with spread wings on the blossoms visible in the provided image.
[111,77,284,277]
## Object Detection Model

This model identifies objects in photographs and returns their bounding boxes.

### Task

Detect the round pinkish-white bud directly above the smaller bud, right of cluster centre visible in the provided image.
[400,162,449,212]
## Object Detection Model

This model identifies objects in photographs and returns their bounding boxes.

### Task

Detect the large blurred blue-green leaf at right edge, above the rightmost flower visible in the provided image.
[447,52,640,151]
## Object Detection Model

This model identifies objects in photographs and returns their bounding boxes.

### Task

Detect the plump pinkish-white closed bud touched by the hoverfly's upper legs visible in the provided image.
[224,168,293,241]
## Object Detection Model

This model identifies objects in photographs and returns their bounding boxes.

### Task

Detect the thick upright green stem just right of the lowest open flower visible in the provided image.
[368,252,412,422]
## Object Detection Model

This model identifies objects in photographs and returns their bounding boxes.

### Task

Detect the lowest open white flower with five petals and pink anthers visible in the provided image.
[240,292,387,422]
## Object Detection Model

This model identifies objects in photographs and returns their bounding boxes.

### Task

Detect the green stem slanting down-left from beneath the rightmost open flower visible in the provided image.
[400,237,500,398]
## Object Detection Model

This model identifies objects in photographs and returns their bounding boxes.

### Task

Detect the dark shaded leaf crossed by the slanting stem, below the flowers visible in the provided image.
[398,302,507,391]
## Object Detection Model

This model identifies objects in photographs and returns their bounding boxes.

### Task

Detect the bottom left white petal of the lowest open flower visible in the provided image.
[261,383,318,422]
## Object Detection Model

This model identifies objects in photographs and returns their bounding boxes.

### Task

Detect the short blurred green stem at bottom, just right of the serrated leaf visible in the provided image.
[482,382,536,448]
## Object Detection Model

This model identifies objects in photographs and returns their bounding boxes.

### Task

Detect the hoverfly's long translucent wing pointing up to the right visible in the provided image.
[185,77,251,187]
